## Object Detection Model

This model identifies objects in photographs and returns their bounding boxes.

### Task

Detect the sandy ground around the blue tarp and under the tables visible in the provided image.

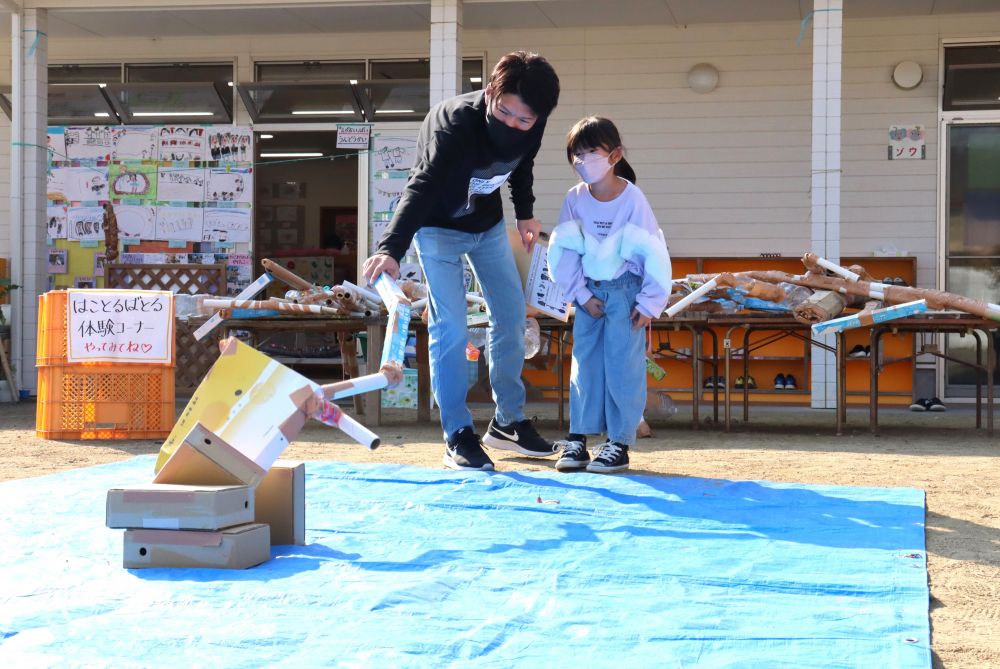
[0,401,1000,669]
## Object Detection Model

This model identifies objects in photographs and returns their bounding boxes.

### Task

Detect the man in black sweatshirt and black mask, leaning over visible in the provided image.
[364,51,559,470]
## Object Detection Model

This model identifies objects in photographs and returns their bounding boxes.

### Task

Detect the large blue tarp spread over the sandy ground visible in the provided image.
[0,456,930,669]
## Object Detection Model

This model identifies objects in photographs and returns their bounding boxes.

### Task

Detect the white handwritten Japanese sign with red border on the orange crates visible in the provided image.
[66,290,174,365]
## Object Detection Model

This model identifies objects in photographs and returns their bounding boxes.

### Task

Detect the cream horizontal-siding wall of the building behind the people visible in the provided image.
[0,12,1000,285]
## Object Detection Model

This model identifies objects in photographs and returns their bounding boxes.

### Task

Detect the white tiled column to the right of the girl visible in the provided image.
[810,0,844,409]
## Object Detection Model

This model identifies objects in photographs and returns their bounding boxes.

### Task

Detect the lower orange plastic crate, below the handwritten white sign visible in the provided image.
[35,358,176,439]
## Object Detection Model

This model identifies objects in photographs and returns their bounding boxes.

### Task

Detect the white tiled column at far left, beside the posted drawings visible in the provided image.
[10,9,49,392]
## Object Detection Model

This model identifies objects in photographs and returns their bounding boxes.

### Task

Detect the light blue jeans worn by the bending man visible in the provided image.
[415,220,525,439]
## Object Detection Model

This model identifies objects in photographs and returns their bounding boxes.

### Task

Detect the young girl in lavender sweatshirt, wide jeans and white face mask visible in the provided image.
[548,116,671,472]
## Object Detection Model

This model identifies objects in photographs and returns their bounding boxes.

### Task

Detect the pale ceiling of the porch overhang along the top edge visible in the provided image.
[25,0,1000,39]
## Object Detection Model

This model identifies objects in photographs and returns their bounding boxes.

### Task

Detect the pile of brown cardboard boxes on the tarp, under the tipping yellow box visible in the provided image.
[107,425,305,569]
